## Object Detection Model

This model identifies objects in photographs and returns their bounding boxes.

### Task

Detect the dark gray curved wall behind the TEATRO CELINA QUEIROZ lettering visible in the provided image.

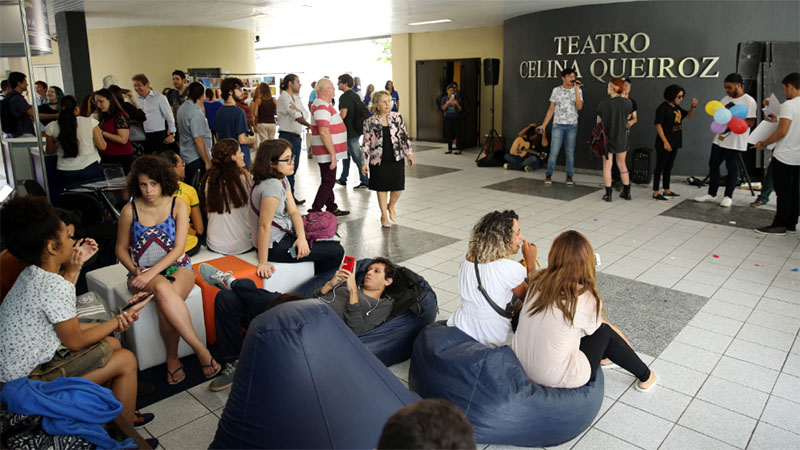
[502,1,800,176]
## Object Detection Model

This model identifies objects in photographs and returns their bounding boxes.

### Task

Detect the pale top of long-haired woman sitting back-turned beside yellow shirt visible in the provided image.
[206,174,253,255]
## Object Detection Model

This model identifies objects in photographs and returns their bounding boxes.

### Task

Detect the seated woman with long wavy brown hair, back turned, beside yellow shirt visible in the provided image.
[199,139,253,255]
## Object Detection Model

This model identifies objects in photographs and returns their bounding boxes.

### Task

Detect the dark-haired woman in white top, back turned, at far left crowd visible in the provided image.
[44,95,106,188]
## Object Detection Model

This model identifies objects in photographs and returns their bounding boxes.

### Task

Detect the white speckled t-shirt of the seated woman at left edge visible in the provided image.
[0,265,77,383]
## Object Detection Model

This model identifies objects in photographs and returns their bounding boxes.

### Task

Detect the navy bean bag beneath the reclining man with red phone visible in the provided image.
[298,259,439,366]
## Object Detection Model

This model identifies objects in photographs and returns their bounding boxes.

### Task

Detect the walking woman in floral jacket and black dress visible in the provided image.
[361,91,414,228]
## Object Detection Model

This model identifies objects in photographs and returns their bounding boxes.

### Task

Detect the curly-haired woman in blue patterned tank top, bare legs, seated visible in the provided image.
[116,155,221,384]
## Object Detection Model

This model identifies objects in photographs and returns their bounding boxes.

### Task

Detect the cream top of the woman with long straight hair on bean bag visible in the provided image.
[511,292,603,388]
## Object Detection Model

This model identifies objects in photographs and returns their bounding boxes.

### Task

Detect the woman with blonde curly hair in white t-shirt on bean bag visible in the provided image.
[447,211,536,347]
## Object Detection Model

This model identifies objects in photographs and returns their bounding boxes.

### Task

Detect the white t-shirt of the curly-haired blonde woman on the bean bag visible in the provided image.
[447,257,527,347]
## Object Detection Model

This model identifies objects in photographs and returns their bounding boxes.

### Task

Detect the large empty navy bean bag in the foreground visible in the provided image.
[216,299,420,449]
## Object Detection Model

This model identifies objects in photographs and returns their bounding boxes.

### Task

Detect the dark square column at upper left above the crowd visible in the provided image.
[56,11,94,101]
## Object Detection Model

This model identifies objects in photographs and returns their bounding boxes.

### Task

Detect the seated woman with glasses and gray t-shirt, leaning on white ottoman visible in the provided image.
[250,139,344,278]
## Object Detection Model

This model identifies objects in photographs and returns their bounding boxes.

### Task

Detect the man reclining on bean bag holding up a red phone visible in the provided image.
[199,258,396,391]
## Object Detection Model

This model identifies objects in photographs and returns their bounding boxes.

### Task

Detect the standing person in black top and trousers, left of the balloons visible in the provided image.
[653,84,697,201]
